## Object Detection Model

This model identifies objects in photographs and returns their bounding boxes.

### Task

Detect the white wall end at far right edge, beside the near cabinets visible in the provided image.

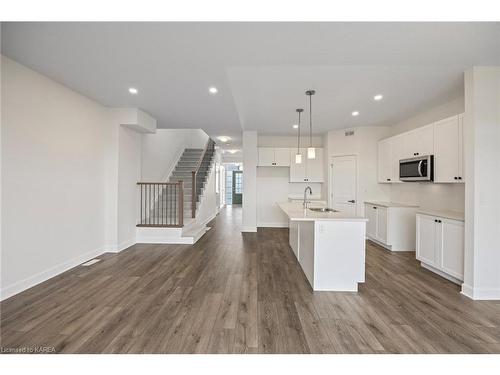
[462,67,500,299]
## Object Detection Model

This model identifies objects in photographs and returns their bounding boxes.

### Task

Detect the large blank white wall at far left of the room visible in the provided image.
[1,57,111,298]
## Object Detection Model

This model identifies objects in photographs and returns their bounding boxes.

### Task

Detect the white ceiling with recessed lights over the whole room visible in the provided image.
[2,22,500,148]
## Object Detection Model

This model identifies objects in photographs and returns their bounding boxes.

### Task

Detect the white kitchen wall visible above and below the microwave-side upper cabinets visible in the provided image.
[390,97,467,212]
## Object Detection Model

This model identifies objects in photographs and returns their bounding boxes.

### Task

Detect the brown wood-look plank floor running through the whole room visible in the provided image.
[0,208,500,353]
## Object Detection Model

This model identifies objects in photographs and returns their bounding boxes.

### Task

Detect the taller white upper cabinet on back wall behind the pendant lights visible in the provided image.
[289,148,324,182]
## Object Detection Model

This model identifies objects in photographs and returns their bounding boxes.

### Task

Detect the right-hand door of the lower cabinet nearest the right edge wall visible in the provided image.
[438,219,464,280]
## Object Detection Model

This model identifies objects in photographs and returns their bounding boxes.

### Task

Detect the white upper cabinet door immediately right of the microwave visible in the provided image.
[434,116,461,182]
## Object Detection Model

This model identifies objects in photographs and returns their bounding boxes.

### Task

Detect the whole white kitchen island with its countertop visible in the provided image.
[278,202,367,291]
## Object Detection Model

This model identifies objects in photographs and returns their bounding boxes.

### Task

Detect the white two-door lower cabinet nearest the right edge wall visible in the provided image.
[416,214,464,281]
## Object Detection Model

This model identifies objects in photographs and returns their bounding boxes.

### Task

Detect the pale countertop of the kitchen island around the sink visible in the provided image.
[277,202,368,221]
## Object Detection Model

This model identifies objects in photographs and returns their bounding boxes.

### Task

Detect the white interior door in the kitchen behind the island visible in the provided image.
[330,155,357,215]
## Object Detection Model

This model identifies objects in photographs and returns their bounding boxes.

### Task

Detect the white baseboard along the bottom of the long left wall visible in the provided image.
[0,248,105,301]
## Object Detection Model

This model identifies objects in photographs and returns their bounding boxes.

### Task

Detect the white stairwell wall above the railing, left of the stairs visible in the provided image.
[142,129,208,182]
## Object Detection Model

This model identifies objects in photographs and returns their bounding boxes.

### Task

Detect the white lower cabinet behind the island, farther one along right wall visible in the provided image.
[365,202,417,251]
